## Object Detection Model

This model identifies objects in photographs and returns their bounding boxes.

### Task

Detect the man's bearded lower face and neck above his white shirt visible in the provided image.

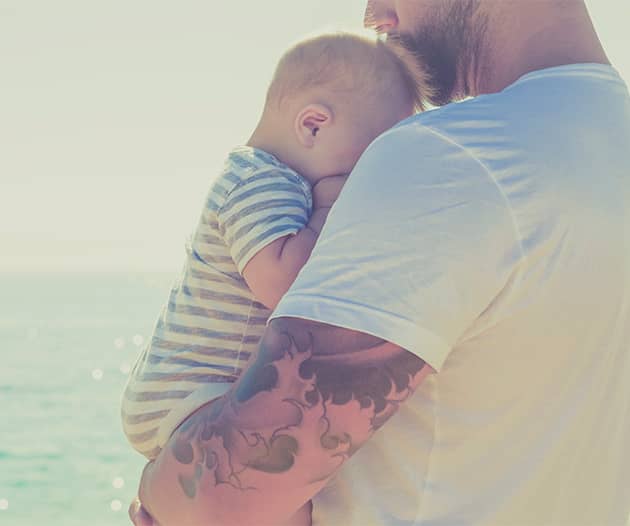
[365,0,609,105]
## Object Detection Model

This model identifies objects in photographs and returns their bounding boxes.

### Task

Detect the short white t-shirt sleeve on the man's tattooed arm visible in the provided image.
[273,125,521,371]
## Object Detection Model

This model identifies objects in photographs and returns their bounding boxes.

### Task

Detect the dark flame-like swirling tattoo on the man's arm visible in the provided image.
[169,319,425,499]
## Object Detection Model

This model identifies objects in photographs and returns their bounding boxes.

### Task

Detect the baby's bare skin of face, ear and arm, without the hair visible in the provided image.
[243,49,413,309]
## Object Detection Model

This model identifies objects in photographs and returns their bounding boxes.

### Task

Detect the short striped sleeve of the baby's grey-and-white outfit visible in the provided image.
[217,168,312,273]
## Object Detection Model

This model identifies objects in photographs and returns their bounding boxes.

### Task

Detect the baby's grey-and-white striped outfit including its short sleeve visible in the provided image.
[122,147,312,459]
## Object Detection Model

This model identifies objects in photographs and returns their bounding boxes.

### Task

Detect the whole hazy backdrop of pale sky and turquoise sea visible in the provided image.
[0,0,630,526]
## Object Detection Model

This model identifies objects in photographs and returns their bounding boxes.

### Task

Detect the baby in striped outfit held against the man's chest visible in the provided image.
[122,33,430,524]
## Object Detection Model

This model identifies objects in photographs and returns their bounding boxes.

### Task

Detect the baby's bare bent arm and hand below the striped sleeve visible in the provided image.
[243,176,347,309]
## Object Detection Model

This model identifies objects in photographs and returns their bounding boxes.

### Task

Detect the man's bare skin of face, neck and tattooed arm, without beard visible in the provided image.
[132,0,608,526]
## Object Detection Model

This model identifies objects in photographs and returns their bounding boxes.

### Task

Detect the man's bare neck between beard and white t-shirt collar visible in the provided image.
[474,1,610,96]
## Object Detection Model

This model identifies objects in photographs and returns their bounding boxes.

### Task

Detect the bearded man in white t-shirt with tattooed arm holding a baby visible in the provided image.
[132,0,630,526]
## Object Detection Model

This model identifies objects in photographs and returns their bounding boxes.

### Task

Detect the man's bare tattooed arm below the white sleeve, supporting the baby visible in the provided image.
[140,318,432,526]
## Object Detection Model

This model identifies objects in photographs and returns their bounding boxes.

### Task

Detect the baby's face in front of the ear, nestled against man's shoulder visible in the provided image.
[320,94,414,176]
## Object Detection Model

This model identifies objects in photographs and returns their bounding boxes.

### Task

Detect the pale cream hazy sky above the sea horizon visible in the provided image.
[0,0,630,273]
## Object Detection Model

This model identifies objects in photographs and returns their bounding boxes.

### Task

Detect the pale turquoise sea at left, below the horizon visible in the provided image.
[0,274,175,526]
